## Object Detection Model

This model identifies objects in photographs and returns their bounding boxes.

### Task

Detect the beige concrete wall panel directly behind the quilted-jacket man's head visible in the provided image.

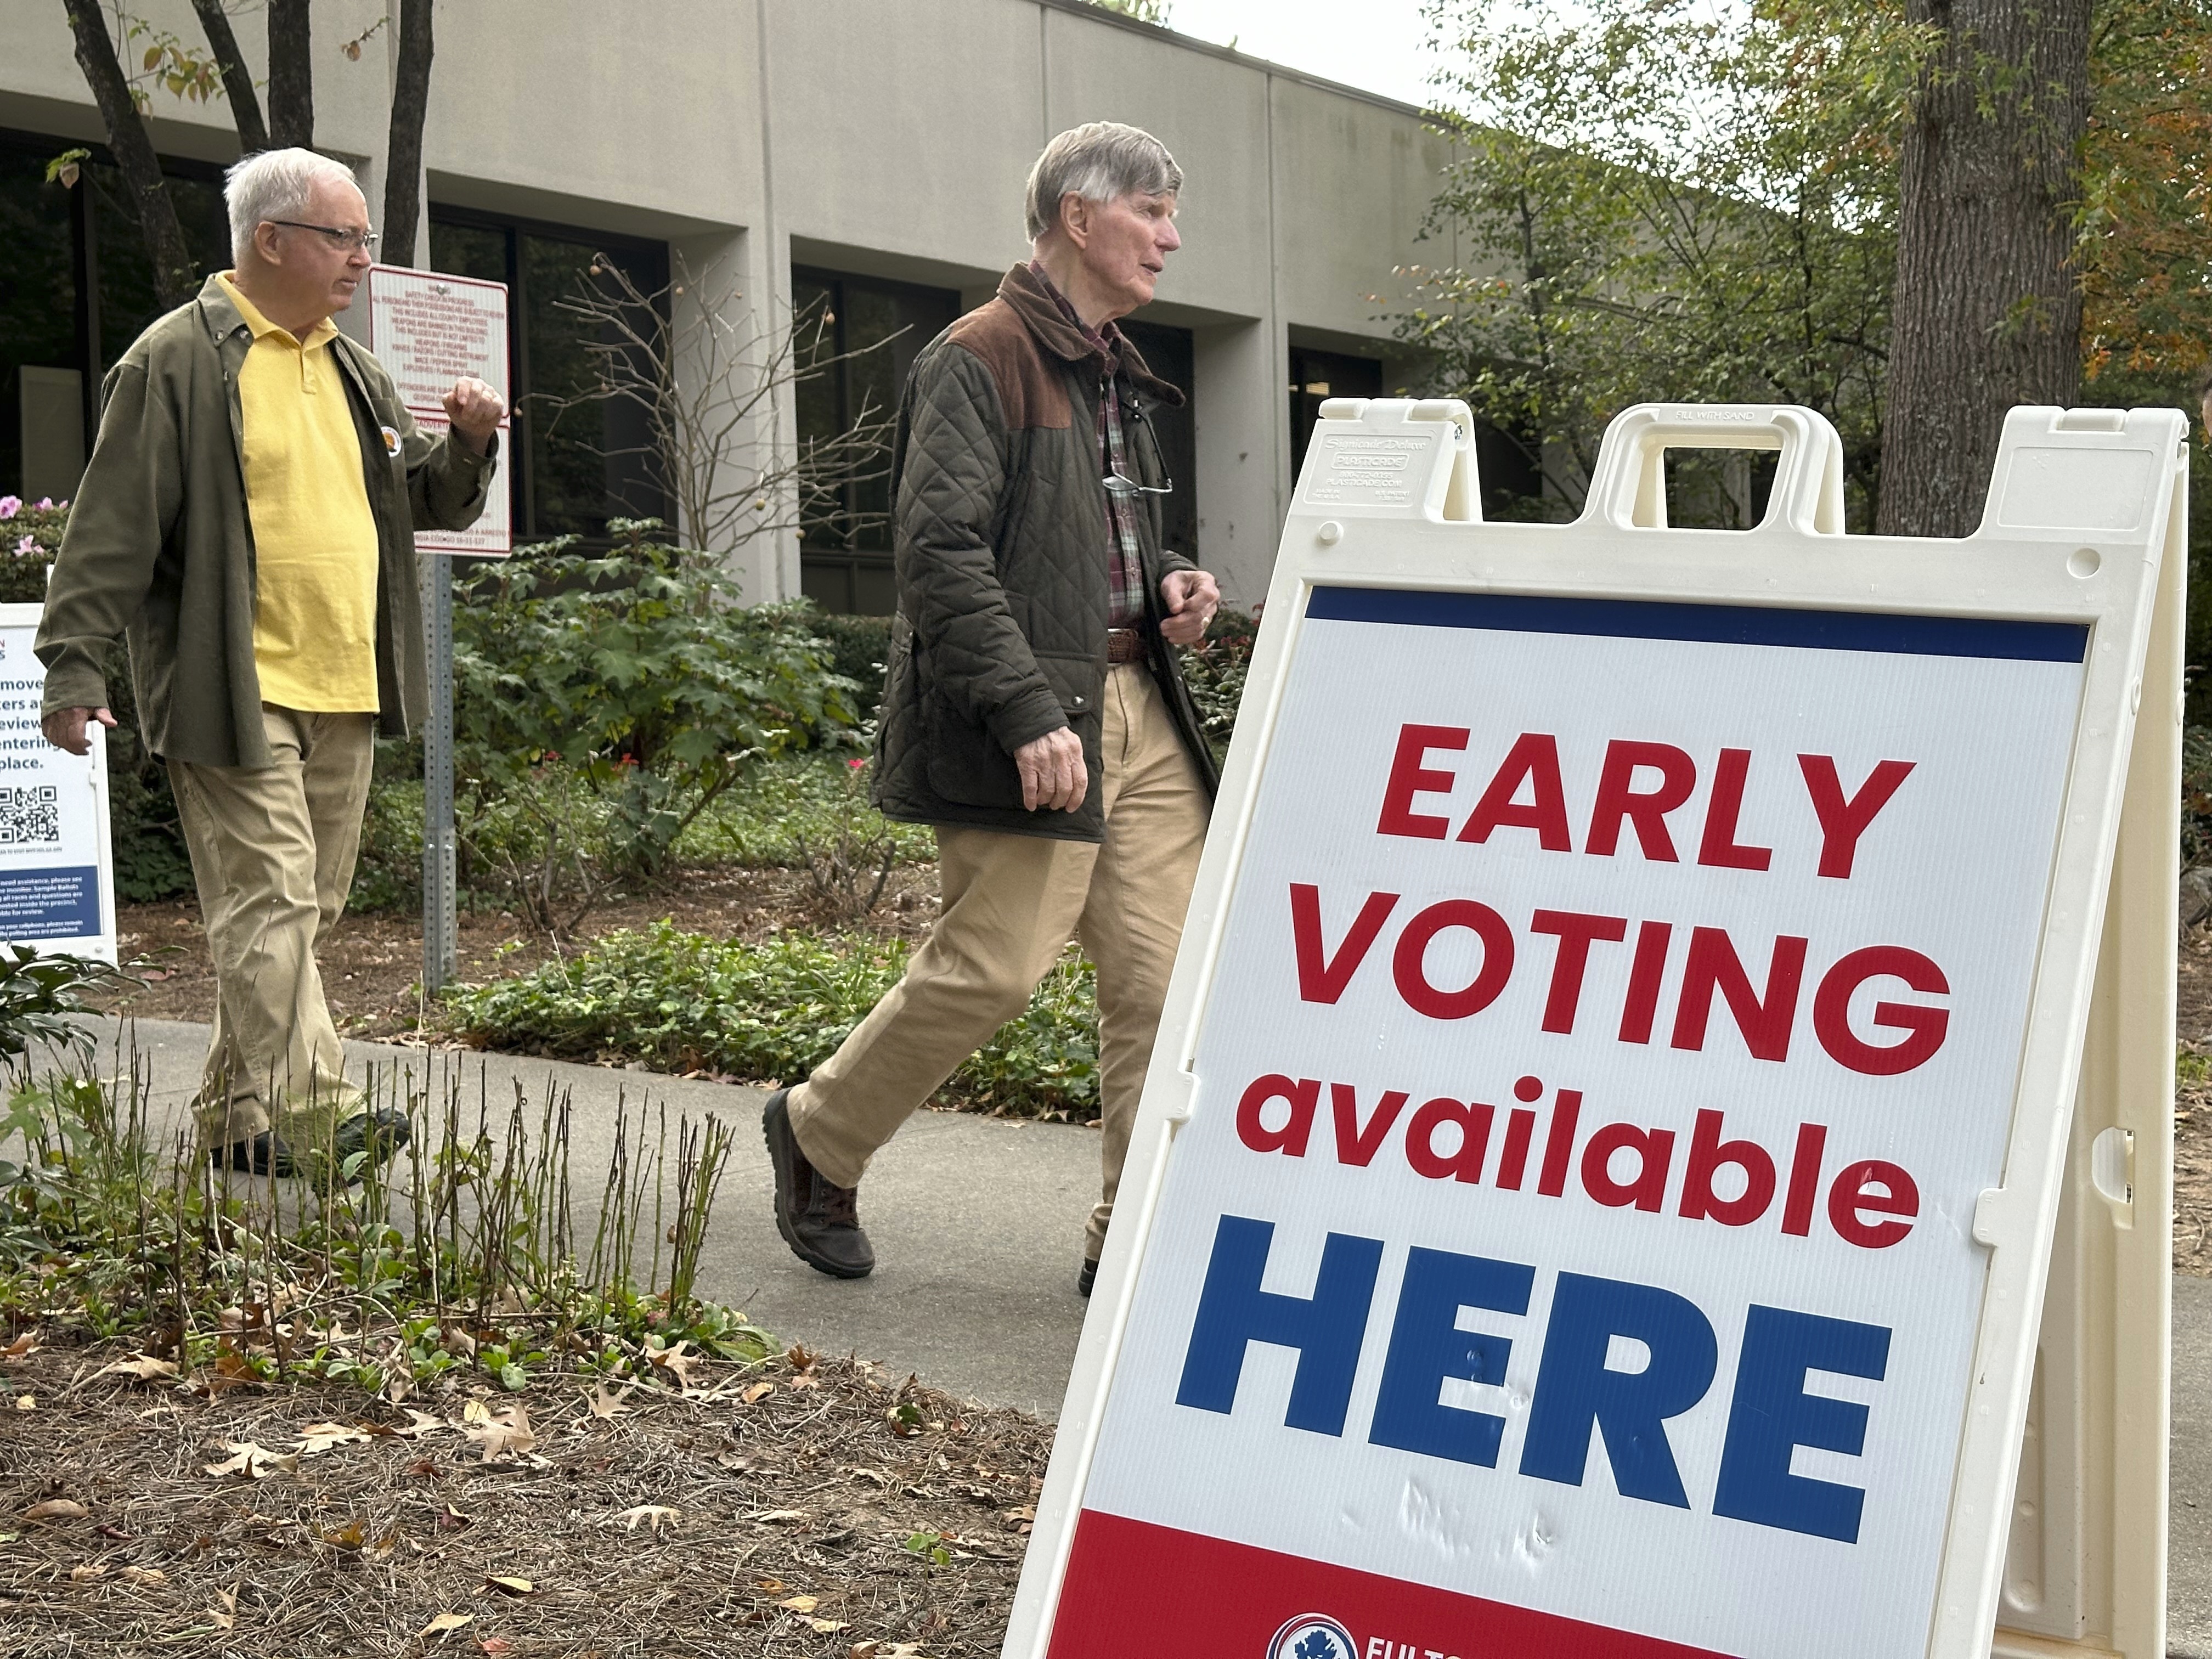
[1042,11,1269,317]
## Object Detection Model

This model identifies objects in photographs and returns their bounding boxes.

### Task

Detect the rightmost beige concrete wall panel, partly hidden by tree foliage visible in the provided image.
[1269,77,1453,338]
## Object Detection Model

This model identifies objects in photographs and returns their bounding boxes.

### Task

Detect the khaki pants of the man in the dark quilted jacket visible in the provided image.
[789,664,1205,1261]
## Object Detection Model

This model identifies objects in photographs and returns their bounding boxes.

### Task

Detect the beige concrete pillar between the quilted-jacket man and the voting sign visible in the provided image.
[1192,323,1290,606]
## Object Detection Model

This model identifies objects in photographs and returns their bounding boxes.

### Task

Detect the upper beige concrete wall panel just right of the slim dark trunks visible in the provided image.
[425,0,770,230]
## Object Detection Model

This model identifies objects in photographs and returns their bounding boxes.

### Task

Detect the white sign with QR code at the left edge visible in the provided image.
[0,604,117,964]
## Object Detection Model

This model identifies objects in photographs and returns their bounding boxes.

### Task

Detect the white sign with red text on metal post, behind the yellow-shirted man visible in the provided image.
[367,266,513,995]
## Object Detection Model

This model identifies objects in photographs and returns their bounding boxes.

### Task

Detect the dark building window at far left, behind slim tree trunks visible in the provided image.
[0,133,230,500]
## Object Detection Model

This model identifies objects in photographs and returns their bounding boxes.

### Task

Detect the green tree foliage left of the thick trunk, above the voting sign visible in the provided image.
[1400,0,1925,522]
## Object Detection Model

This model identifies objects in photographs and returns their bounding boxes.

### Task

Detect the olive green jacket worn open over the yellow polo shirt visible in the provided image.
[38,276,493,768]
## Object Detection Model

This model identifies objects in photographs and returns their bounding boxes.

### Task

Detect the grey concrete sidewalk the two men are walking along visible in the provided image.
[30,1020,2212,1659]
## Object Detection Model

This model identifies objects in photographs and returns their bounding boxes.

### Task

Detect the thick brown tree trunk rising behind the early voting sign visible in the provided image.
[1876,0,2090,535]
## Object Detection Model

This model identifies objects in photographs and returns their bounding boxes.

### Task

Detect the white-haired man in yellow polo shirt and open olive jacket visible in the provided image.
[38,150,504,1175]
